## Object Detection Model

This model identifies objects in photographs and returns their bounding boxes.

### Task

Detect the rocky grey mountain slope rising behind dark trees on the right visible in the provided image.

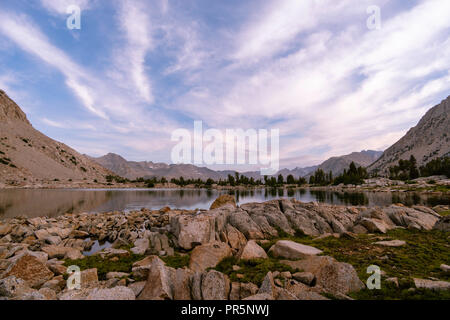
[368,97,450,175]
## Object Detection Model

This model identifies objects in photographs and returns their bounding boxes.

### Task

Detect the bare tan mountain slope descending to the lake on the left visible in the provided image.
[0,90,111,185]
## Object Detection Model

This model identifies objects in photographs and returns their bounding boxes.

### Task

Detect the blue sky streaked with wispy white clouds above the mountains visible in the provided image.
[0,0,450,170]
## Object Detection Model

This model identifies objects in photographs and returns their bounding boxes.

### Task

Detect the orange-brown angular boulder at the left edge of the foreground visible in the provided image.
[1,254,54,287]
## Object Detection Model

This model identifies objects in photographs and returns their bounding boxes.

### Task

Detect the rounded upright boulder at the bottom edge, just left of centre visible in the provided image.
[201,270,231,300]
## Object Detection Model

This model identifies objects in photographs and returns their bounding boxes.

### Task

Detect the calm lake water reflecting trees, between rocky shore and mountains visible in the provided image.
[0,189,450,219]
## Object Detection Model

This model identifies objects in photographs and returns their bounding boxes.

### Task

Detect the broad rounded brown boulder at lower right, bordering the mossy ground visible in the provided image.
[281,256,364,294]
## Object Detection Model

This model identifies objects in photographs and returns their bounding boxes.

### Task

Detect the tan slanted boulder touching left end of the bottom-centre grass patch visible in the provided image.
[189,241,232,272]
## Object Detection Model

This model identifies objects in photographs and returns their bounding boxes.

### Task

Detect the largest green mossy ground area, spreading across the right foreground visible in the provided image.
[261,229,450,299]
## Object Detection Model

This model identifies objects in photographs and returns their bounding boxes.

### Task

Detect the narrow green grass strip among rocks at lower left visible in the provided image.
[64,253,144,280]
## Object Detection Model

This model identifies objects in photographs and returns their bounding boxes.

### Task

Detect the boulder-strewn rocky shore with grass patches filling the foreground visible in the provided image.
[0,195,450,300]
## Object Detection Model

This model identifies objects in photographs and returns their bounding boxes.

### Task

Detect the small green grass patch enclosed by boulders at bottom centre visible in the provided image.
[214,257,300,286]
